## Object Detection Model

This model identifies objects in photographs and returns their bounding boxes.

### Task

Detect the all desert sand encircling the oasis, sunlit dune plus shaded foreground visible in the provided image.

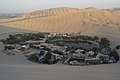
[0,8,120,80]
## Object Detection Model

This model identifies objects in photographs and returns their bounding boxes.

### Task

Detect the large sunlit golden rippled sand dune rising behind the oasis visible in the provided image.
[0,8,120,47]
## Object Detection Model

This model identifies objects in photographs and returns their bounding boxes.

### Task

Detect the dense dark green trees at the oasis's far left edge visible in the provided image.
[1,33,48,44]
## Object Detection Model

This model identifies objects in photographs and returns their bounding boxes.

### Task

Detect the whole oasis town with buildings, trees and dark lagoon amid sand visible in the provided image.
[1,33,120,66]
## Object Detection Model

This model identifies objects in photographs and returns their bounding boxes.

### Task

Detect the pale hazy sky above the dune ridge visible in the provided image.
[0,0,120,13]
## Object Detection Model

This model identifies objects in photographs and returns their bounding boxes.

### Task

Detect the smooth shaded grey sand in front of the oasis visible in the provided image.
[0,43,120,80]
